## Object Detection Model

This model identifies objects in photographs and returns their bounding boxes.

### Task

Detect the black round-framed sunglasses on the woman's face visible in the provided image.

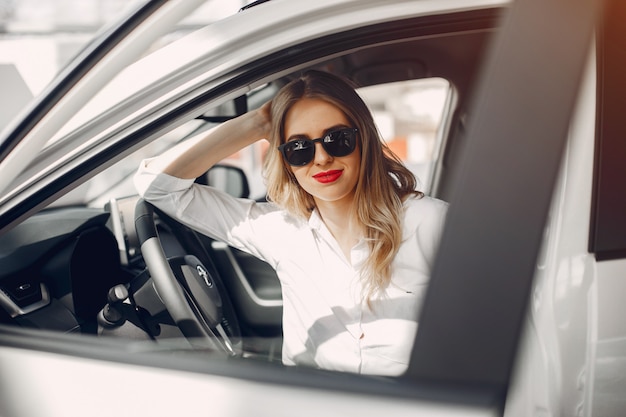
[278,128,359,167]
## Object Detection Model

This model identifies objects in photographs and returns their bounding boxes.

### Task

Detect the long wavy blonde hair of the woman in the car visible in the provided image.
[264,71,423,301]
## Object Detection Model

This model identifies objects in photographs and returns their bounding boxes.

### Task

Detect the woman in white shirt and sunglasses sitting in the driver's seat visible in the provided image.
[136,71,446,375]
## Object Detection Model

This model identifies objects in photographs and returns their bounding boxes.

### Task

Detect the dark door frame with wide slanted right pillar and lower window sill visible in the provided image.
[0,0,597,415]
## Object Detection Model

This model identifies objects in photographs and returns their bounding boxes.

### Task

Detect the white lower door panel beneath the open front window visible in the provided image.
[0,347,497,417]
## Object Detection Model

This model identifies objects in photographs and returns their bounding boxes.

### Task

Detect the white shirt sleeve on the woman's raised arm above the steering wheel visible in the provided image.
[134,159,281,267]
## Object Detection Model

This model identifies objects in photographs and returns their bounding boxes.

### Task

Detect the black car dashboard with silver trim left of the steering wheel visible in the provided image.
[0,196,190,338]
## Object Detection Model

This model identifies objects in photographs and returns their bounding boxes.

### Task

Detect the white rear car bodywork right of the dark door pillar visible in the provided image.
[505,47,626,417]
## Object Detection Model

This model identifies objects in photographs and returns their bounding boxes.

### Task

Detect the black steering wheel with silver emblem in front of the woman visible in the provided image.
[135,199,241,356]
